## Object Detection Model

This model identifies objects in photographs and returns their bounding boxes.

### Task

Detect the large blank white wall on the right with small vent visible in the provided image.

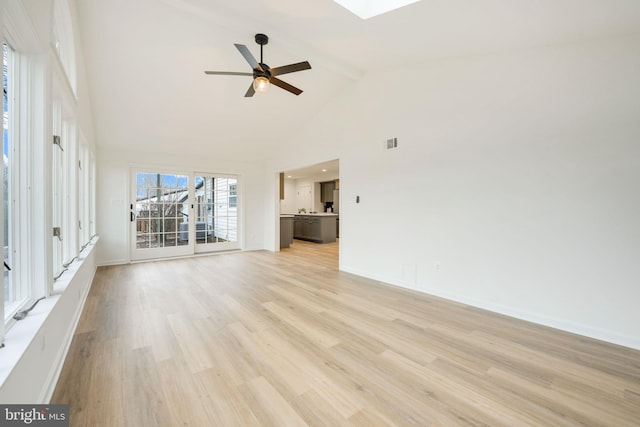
[273,35,640,348]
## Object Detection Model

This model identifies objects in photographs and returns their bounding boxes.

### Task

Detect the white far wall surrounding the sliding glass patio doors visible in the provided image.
[96,148,268,265]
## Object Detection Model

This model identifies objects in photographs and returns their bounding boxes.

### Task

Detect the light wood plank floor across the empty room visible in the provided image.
[52,241,640,427]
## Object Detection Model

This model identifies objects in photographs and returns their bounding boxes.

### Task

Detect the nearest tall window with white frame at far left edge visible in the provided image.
[0,2,47,342]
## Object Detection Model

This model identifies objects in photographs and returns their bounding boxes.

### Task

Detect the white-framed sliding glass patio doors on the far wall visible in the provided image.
[129,169,240,261]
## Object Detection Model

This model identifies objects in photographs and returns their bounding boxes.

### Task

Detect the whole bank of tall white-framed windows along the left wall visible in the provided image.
[0,0,96,357]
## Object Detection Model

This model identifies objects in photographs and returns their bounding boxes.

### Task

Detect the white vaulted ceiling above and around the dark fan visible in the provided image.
[77,0,640,161]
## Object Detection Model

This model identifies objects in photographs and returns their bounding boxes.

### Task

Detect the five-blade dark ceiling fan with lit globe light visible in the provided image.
[204,34,311,98]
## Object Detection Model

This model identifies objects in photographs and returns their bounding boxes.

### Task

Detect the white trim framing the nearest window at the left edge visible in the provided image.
[2,1,49,333]
